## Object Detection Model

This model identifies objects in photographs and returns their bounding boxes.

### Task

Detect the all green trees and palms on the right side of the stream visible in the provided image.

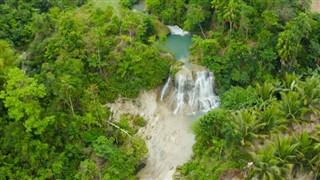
[147,0,320,179]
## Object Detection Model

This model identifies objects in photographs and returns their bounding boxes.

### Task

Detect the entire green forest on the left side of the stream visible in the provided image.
[0,0,173,179]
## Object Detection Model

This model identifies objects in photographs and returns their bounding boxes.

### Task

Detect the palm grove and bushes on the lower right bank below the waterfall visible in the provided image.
[181,72,320,179]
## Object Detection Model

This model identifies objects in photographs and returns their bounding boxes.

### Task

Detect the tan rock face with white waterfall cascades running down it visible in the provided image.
[160,65,219,114]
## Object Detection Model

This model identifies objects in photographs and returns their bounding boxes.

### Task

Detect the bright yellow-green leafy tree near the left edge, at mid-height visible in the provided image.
[0,68,54,134]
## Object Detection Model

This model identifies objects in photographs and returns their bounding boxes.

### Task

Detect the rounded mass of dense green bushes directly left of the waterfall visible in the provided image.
[109,43,172,97]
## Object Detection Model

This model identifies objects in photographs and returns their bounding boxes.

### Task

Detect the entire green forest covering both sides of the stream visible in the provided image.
[0,0,320,180]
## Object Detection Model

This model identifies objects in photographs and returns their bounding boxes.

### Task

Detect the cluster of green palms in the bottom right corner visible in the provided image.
[251,132,319,178]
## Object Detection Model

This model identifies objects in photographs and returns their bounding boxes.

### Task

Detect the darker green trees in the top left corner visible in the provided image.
[0,0,86,48]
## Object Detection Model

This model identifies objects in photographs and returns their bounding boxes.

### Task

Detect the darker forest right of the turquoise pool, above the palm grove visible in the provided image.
[147,0,319,93]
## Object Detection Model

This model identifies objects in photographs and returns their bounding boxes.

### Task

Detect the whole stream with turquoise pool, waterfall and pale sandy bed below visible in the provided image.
[109,5,219,180]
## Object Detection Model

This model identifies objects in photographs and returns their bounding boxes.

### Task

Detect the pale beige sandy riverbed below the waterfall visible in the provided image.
[109,90,195,180]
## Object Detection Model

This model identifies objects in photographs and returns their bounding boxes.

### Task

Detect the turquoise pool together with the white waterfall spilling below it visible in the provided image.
[160,26,219,114]
